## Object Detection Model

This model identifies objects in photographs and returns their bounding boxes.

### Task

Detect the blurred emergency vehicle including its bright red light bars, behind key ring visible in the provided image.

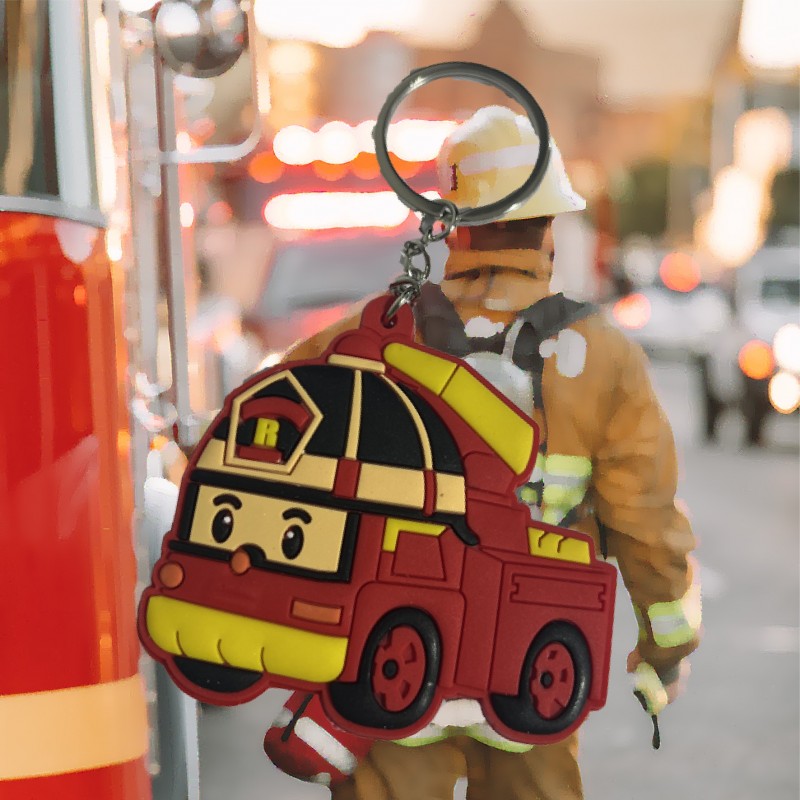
[225,118,456,361]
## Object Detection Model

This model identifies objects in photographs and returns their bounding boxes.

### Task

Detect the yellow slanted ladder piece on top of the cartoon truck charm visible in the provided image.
[383,343,534,475]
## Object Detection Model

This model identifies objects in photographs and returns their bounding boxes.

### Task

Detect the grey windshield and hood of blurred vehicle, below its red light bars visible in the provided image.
[246,230,443,362]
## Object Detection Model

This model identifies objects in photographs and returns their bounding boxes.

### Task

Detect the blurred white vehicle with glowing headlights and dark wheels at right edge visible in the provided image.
[695,247,800,444]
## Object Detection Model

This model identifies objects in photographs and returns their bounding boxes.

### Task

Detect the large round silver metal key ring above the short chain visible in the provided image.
[372,61,550,225]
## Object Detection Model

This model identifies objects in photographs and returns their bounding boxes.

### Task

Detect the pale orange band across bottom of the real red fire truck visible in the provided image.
[0,675,147,780]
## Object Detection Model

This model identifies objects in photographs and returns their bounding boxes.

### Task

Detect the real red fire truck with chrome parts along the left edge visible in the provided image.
[0,0,258,800]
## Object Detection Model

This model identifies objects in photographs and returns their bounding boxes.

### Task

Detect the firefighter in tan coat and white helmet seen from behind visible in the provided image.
[265,106,700,800]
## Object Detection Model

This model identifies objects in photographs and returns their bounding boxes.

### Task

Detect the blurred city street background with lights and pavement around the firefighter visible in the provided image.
[121,0,800,800]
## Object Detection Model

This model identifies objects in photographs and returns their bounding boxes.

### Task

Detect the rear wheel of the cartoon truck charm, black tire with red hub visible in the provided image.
[490,622,592,736]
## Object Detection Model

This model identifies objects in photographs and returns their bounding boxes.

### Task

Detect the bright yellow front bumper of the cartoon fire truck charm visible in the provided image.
[147,596,348,683]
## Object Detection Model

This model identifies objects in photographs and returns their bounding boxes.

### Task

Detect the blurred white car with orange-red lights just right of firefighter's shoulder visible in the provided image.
[607,251,730,358]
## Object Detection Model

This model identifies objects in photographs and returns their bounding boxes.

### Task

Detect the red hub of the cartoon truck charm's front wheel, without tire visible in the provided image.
[372,625,427,712]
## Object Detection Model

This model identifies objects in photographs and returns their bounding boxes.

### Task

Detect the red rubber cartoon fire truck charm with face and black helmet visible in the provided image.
[139,295,616,744]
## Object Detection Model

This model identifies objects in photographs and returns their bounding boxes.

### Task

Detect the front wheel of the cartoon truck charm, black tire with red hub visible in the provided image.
[328,608,442,730]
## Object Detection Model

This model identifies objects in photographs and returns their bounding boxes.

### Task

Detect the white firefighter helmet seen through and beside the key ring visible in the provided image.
[437,106,586,220]
